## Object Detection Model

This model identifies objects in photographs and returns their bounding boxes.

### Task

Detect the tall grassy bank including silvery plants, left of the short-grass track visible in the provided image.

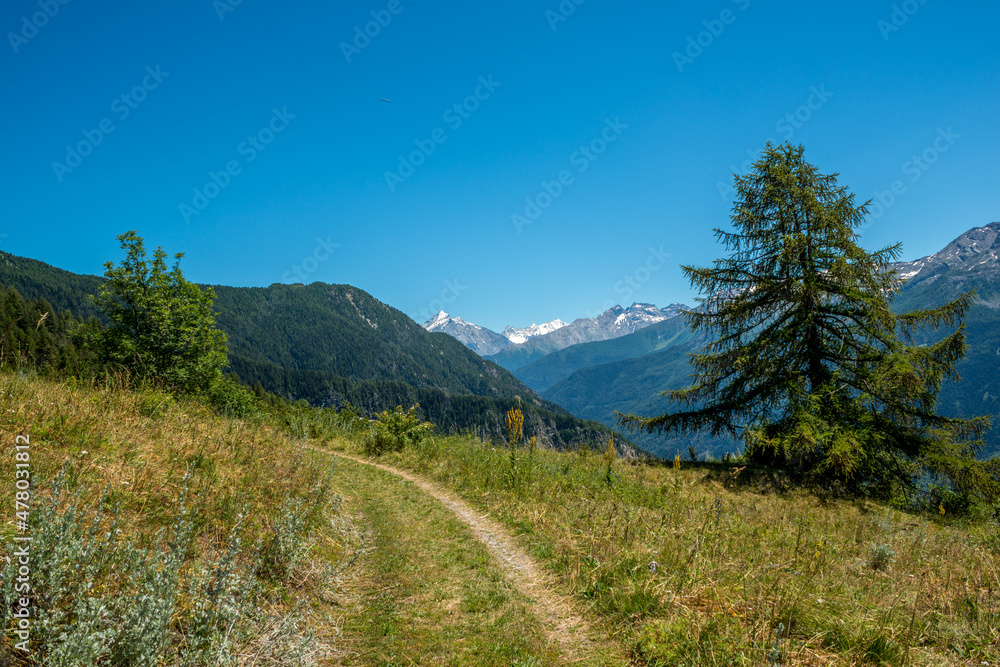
[0,373,358,666]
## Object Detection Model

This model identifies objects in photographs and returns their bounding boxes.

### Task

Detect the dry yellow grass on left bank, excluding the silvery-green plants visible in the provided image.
[0,372,352,664]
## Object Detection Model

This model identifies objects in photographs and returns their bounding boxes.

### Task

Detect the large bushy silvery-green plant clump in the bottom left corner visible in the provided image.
[0,467,192,667]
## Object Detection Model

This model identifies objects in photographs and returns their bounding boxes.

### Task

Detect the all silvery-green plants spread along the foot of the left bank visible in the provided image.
[0,466,330,667]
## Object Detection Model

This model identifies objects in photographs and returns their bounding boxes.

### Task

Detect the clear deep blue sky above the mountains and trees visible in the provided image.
[0,0,1000,329]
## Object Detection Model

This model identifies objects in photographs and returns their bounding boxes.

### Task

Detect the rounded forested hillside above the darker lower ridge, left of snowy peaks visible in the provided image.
[213,283,530,399]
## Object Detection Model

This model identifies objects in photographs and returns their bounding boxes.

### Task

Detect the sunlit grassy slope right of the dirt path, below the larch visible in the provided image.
[338,437,1000,665]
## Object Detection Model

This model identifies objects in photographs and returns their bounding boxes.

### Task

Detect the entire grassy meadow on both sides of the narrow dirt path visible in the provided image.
[0,371,1000,666]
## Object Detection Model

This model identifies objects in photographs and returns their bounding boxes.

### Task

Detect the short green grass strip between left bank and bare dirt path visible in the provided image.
[334,461,572,667]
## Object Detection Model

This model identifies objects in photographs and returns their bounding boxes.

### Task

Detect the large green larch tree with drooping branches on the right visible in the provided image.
[619,144,995,495]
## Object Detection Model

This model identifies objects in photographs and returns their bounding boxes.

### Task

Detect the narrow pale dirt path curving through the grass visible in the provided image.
[309,447,618,664]
